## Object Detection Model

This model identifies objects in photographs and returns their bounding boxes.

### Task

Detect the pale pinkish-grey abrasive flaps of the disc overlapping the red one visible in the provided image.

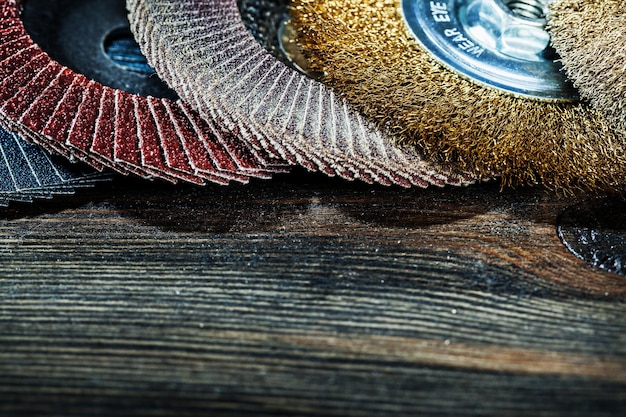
[127,0,469,186]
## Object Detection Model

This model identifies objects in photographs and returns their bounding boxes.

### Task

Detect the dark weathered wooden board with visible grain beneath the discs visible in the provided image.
[0,172,626,416]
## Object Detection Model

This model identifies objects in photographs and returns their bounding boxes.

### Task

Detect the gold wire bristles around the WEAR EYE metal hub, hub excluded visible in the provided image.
[292,0,626,190]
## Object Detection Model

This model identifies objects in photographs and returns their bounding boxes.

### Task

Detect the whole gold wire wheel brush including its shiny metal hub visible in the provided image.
[292,0,626,190]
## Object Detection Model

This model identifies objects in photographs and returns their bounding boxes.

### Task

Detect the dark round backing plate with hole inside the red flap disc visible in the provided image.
[21,0,178,100]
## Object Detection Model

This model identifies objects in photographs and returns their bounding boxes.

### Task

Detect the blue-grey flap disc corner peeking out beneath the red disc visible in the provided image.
[0,129,110,206]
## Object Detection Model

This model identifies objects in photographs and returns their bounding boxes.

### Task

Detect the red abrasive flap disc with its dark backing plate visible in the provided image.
[0,0,285,184]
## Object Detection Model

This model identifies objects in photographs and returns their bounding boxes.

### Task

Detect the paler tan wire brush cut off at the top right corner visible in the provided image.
[548,0,626,132]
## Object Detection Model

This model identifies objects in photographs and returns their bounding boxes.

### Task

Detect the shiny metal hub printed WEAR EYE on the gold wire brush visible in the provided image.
[402,0,578,101]
